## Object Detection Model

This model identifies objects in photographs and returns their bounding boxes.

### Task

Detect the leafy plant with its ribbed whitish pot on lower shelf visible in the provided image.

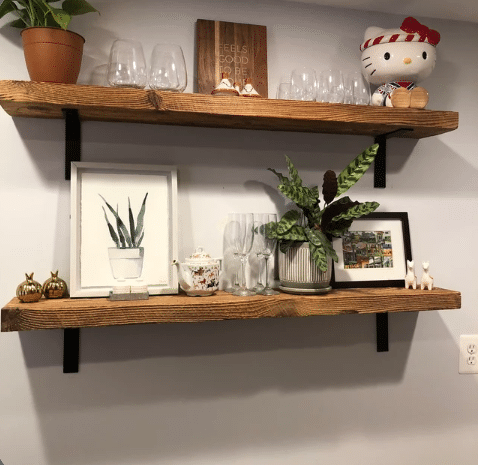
[268,144,379,293]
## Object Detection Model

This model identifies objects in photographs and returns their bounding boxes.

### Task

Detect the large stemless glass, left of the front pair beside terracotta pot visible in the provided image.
[107,39,147,89]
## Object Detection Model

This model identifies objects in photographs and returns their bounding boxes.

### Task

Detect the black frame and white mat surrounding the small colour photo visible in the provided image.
[331,212,412,289]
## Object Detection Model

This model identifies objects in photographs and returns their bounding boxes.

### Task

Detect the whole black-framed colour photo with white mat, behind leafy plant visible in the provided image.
[332,213,412,288]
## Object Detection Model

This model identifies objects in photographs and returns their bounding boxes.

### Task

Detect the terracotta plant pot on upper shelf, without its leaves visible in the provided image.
[21,27,85,84]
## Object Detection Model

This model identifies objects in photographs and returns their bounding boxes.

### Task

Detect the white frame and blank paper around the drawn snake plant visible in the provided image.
[69,162,178,298]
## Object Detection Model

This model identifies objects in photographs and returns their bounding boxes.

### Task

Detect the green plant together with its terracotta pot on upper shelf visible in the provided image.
[0,0,97,84]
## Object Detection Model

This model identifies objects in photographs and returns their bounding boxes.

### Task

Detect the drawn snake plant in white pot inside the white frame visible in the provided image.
[100,192,148,279]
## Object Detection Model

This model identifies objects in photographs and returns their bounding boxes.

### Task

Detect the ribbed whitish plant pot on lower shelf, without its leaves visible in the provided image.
[278,242,332,293]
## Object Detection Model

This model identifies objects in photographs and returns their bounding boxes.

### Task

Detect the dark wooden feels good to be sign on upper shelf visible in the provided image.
[196,19,268,98]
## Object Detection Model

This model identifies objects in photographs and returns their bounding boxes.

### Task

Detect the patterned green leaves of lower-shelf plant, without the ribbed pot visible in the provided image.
[268,144,379,271]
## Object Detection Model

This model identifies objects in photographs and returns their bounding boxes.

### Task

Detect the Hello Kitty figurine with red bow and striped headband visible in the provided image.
[360,16,440,108]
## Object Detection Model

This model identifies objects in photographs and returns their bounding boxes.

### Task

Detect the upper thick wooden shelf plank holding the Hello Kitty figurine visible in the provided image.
[0,81,458,139]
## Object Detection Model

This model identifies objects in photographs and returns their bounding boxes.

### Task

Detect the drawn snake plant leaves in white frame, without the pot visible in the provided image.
[98,192,148,249]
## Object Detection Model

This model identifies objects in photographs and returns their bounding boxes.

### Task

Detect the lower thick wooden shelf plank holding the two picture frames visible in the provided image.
[1,288,461,331]
